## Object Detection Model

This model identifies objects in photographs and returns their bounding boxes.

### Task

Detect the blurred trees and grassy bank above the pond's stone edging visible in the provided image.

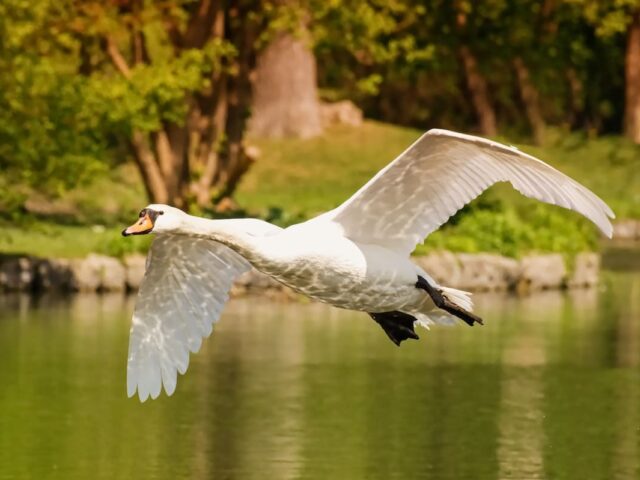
[0,0,640,256]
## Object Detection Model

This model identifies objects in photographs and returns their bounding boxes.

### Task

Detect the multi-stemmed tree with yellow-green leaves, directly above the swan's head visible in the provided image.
[72,0,259,208]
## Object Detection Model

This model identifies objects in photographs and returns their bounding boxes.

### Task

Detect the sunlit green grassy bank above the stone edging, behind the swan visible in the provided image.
[0,122,640,257]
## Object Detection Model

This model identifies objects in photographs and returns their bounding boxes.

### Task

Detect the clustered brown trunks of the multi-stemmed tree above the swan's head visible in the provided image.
[104,0,258,209]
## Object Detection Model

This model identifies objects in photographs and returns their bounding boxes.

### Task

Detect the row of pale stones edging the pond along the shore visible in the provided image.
[0,252,600,296]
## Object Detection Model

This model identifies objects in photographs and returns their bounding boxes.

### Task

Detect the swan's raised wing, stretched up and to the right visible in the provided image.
[318,130,614,254]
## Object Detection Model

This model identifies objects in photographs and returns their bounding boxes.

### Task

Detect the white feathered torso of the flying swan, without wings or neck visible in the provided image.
[256,228,428,313]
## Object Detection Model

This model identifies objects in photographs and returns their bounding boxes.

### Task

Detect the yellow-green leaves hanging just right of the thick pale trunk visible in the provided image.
[307,0,435,99]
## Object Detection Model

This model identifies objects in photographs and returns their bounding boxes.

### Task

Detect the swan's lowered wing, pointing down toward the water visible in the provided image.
[127,235,249,402]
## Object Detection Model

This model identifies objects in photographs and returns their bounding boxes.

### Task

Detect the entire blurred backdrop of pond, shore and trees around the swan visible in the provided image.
[0,0,640,480]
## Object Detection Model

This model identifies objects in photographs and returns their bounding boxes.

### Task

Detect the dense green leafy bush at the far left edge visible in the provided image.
[0,0,106,195]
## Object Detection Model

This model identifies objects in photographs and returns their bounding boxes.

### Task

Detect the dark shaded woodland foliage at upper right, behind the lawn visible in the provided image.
[298,0,640,135]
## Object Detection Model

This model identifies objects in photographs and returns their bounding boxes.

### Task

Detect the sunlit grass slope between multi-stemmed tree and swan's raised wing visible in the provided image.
[236,122,420,217]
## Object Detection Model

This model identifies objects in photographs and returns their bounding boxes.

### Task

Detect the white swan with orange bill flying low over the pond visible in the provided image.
[122,130,614,401]
